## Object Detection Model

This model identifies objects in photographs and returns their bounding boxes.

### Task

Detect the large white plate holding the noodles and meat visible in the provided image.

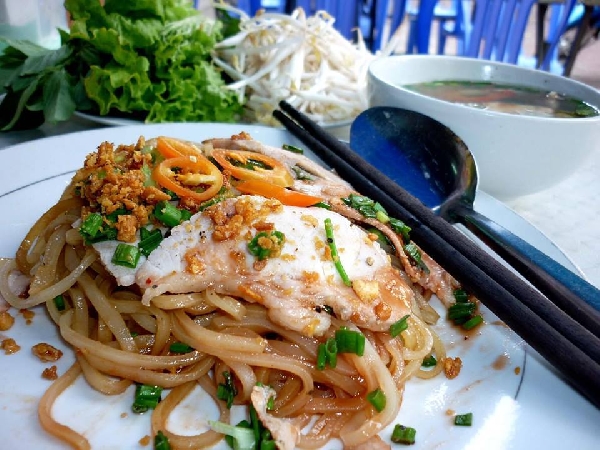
[0,124,600,450]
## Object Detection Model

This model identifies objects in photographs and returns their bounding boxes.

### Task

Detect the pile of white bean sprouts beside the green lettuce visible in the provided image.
[213,4,390,125]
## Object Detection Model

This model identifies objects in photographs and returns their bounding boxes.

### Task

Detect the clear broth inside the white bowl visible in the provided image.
[404,81,599,118]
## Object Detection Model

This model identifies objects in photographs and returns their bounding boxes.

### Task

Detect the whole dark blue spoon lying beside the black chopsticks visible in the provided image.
[350,107,600,329]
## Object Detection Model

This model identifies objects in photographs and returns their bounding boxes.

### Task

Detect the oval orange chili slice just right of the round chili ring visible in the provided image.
[211,148,294,187]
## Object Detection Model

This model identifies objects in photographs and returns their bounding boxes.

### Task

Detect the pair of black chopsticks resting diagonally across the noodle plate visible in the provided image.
[273,101,600,407]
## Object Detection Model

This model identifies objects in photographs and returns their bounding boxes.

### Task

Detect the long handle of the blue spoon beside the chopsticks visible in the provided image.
[453,207,600,336]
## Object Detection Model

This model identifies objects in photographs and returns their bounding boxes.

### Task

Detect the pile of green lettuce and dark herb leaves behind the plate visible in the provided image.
[0,0,242,130]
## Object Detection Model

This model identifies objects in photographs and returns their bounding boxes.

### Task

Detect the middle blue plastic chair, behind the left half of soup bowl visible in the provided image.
[406,0,471,55]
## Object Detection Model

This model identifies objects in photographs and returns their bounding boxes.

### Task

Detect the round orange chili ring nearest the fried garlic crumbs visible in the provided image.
[152,155,223,201]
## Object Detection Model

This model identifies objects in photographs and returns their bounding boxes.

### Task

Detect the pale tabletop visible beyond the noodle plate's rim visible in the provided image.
[0,117,600,287]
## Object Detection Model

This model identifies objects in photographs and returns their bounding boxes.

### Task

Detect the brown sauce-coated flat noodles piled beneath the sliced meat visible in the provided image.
[0,141,445,449]
